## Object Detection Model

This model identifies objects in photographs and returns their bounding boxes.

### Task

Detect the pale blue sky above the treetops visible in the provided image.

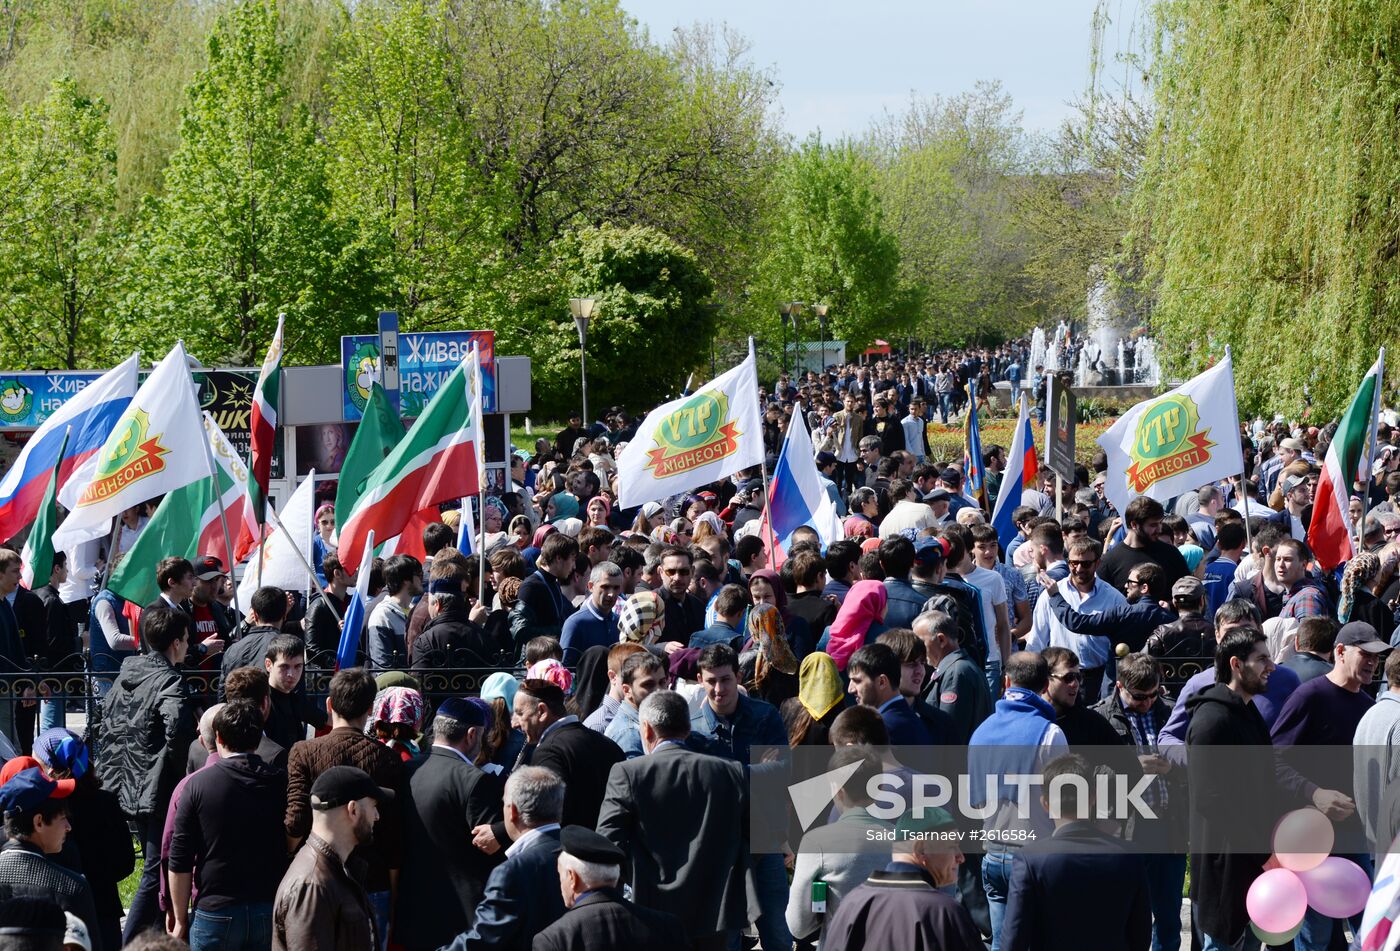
[622,0,1142,139]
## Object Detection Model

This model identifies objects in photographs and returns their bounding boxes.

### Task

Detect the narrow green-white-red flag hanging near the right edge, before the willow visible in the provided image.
[1308,350,1386,571]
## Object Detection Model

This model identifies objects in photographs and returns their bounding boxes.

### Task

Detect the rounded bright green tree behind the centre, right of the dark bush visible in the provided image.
[750,139,916,349]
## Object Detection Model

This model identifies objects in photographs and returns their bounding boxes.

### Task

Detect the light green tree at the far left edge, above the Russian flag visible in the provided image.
[0,80,130,370]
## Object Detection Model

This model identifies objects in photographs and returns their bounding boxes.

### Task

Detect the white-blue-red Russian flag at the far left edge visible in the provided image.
[0,353,139,542]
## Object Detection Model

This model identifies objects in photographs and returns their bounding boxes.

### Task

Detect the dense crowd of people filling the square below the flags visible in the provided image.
[0,346,1400,951]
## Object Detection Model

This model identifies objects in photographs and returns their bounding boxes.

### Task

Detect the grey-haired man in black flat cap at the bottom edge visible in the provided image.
[533,825,680,951]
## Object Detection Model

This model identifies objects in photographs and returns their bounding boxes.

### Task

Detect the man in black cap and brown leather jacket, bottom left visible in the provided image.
[272,766,393,951]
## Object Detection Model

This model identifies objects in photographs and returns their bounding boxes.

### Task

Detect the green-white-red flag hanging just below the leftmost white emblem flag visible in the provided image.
[108,413,260,605]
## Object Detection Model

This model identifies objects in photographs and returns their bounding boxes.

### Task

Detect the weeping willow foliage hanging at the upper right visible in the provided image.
[1133,0,1400,412]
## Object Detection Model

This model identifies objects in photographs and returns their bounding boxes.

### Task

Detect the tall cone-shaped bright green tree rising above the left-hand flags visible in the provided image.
[130,0,374,366]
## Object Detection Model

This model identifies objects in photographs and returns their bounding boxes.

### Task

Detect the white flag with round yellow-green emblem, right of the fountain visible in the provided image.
[1096,355,1245,521]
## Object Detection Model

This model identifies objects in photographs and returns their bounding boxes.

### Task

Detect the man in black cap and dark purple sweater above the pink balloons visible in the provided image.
[1271,620,1390,951]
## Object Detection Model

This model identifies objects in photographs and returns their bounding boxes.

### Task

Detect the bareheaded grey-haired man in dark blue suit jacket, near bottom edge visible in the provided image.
[447,766,565,951]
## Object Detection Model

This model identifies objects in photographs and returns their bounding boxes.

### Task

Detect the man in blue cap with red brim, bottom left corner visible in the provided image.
[0,761,97,931]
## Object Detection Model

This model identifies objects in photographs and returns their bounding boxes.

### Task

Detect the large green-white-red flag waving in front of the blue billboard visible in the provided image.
[339,352,482,571]
